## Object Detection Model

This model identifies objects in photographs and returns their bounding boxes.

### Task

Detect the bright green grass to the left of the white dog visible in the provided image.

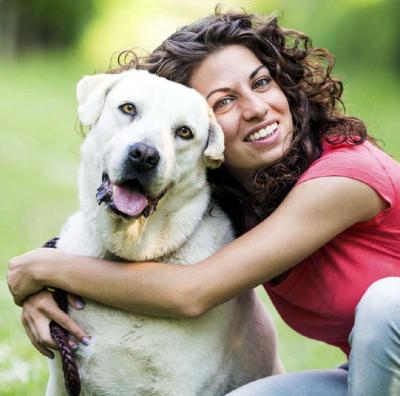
[0,57,88,395]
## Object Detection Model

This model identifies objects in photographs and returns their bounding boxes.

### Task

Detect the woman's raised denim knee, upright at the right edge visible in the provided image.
[348,277,400,396]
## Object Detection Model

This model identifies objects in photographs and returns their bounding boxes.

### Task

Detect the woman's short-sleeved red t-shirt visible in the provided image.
[265,142,400,355]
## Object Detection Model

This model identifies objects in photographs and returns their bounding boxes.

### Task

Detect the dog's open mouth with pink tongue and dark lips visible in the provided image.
[96,173,164,218]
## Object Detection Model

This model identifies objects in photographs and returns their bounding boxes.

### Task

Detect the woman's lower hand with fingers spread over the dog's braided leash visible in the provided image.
[21,290,89,359]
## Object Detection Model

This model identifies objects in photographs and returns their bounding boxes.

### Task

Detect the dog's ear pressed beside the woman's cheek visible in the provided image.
[204,109,225,169]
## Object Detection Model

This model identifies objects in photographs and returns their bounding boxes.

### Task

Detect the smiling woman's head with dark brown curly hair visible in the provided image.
[138,11,373,229]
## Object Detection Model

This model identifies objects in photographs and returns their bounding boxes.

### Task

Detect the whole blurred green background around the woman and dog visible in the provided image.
[0,0,400,395]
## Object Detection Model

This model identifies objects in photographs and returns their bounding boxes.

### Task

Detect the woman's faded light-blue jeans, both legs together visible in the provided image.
[229,277,400,396]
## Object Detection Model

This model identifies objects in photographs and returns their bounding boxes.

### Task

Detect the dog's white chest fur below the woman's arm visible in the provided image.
[74,303,238,396]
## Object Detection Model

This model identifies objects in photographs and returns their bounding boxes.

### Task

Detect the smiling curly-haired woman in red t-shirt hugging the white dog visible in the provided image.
[9,12,400,396]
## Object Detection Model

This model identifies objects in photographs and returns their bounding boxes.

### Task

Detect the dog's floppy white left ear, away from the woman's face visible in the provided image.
[76,74,121,125]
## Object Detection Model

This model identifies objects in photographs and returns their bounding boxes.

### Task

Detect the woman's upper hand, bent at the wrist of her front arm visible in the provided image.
[7,248,67,306]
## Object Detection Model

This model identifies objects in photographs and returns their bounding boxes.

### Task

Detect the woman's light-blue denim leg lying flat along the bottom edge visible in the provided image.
[227,369,347,396]
